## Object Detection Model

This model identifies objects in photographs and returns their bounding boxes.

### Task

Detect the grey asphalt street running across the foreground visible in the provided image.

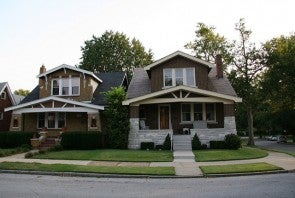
[0,173,295,198]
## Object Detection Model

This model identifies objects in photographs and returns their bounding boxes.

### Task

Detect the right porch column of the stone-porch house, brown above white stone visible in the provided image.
[224,104,237,134]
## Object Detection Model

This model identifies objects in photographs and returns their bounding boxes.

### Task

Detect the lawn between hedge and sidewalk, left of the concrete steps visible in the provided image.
[33,149,173,162]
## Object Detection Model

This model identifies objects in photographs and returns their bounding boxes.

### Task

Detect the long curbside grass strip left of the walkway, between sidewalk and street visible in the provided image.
[0,162,175,175]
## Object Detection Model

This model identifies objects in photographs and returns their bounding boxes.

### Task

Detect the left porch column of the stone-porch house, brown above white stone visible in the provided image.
[128,106,140,149]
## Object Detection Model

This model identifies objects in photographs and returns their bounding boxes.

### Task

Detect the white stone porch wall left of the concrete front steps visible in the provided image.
[128,118,173,149]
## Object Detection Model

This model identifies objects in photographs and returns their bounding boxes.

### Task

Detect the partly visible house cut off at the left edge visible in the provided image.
[0,82,24,131]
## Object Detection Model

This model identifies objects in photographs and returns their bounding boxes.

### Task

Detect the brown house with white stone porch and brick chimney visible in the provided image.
[123,51,242,149]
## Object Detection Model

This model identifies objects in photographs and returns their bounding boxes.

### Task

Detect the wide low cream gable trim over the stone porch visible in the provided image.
[123,85,242,105]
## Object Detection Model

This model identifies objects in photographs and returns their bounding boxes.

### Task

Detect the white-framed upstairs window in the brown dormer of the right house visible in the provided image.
[163,67,196,88]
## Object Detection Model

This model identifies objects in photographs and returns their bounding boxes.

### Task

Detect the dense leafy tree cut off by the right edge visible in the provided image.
[261,33,295,141]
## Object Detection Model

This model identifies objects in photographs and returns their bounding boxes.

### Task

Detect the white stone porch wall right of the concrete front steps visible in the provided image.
[190,116,237,146]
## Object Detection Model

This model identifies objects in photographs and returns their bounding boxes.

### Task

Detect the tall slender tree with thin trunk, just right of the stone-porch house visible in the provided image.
[229,19,264,145]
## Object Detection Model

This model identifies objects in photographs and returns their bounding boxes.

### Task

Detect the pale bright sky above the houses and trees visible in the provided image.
[0,0,295,90]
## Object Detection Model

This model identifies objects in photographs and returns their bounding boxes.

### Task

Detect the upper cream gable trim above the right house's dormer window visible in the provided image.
[144,51,214,70]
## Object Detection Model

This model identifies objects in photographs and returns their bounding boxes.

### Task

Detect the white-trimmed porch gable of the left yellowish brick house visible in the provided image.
[5,96,104,113]
